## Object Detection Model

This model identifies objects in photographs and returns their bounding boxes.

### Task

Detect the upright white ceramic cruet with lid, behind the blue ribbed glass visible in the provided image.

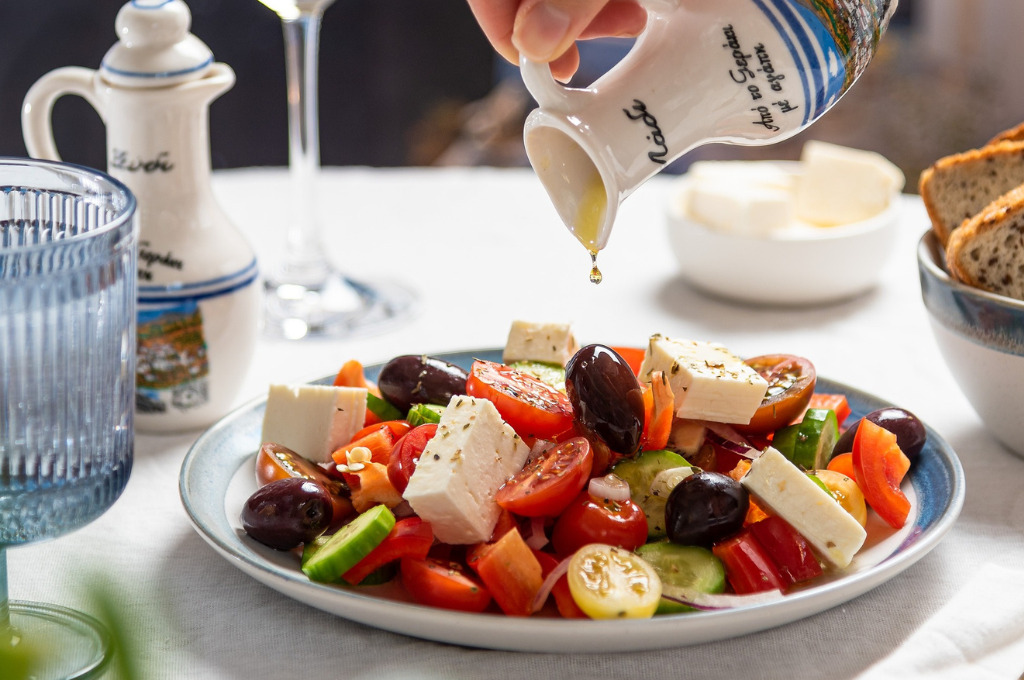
[22,0,260,431]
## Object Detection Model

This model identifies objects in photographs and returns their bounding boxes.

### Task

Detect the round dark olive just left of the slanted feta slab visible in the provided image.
[665,471,751,547]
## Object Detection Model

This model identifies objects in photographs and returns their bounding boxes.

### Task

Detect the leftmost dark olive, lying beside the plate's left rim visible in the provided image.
[242,477,333,550]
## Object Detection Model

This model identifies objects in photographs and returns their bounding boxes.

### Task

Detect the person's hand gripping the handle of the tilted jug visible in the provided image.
[468,0,647,82]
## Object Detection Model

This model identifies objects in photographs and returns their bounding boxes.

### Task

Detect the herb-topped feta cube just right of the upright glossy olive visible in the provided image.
[640,335,768,424]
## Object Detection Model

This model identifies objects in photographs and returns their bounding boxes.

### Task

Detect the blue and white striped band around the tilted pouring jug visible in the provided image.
[754,0,846,125]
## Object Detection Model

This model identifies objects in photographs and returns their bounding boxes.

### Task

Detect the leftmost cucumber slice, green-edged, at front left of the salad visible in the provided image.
[302,505,395,583]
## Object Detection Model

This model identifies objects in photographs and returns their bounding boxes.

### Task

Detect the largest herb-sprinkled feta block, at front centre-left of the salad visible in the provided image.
[403,395,529,545]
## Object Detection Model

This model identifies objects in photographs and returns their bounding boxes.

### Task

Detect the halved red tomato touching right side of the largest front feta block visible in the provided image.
[495,437,594,517]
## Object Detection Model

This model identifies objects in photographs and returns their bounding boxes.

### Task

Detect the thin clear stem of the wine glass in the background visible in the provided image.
[282,7,330,286]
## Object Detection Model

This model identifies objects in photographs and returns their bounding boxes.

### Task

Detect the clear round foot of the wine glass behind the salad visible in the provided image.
[263,271,416,340]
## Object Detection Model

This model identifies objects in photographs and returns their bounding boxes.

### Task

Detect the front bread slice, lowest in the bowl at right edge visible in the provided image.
[946,186,1024,300]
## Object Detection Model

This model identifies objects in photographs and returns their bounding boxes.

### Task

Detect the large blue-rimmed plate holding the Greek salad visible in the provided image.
[179,349,965,652]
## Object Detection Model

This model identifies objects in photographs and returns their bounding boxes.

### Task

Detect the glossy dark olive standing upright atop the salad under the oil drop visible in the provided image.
[565,345,644,456]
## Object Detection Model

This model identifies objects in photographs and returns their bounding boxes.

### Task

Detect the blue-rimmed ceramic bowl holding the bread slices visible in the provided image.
[918,231,1024,456]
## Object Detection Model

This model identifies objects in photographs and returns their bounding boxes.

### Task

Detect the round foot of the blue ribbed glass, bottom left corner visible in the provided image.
[0,600,113,680]
